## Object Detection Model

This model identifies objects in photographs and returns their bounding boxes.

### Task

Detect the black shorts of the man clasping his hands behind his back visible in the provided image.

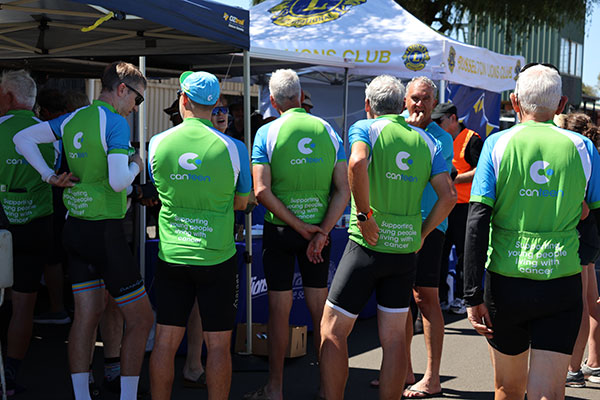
[263,222,331,291]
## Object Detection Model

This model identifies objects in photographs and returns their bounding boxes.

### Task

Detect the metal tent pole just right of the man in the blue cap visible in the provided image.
[244,50,252,354]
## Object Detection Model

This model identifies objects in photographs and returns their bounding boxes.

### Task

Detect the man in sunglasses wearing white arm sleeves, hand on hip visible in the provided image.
[13,62,153,400]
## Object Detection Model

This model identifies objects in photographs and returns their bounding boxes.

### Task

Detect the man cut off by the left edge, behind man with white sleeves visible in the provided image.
[0,70,56,396]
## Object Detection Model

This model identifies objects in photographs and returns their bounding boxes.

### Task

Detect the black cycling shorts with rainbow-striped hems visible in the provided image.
[63,217,146,307]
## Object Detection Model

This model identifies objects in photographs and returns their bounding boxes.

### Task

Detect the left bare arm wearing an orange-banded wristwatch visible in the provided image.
[348,142,379,246]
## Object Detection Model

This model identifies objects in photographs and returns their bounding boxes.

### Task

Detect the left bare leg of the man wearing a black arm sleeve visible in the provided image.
[489,346,528,400]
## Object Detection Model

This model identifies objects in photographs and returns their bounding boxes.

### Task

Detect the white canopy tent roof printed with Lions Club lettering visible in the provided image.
[250,0,524,92]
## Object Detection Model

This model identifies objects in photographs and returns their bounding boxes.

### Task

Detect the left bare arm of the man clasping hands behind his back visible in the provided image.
[252,164,325,240]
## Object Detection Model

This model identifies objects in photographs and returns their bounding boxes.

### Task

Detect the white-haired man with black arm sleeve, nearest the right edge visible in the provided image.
[464,64,600,399]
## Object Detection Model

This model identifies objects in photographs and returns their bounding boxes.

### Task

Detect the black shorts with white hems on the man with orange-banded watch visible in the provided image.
[327,240,416,318]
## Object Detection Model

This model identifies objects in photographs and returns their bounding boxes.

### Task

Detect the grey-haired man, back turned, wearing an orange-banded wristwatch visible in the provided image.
[321,75,456,400]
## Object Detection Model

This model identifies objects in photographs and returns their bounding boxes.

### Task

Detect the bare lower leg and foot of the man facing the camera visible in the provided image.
[404,287,444,398]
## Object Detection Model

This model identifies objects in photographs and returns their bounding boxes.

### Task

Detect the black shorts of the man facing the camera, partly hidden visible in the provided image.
[415,229,445,288]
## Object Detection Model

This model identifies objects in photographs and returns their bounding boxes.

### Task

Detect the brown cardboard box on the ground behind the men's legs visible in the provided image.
[235,324,307,358]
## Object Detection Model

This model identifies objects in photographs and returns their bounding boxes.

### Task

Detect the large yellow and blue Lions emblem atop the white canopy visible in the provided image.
[269,0,367,28]
